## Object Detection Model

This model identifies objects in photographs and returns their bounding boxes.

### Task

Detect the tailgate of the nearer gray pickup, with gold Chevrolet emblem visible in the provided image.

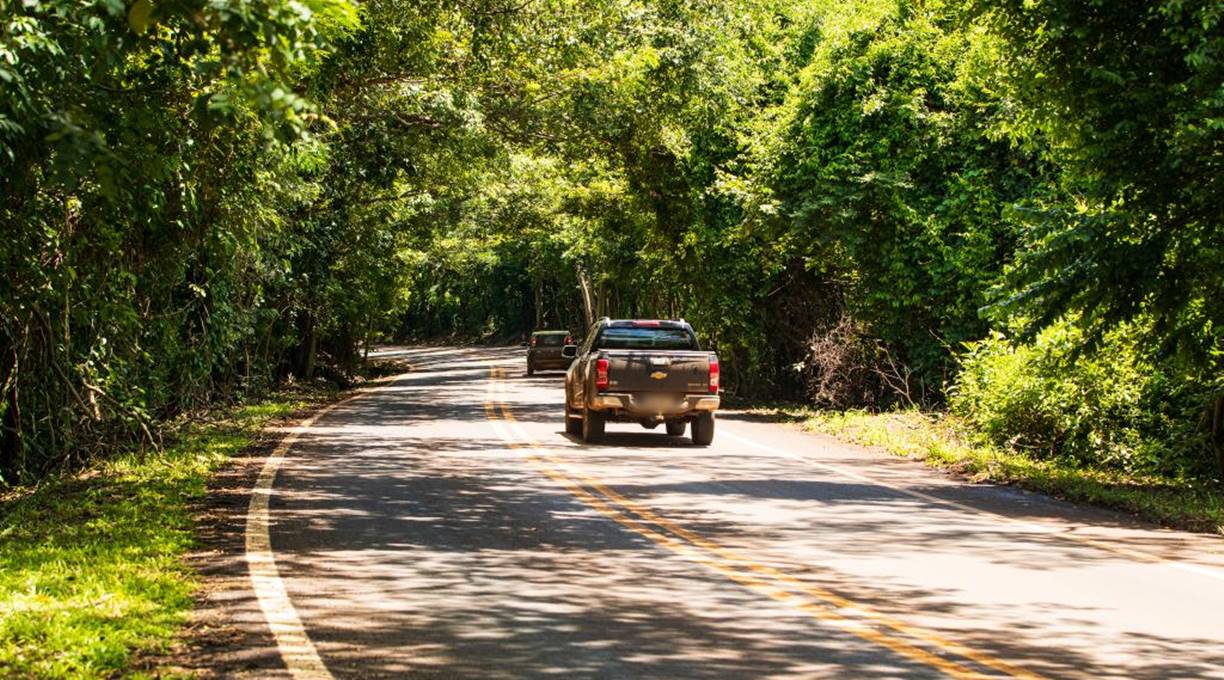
[600,350,711,394]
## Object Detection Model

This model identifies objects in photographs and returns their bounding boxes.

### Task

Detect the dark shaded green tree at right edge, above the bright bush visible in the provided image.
[978,0,1224,472]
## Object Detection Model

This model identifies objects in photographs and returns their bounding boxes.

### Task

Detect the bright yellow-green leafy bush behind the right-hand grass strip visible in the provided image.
[950,322,1214,477]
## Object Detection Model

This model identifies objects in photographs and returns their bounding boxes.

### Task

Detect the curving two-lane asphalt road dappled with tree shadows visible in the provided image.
[247,347,1224,679]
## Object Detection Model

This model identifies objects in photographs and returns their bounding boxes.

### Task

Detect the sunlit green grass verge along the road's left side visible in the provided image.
[0,391,330,678]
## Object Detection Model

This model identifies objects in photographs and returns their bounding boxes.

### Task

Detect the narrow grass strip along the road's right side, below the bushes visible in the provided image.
[753,405,1224,533]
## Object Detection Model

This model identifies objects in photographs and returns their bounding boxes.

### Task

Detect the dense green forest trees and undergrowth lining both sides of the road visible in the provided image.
[0,0,1224,483]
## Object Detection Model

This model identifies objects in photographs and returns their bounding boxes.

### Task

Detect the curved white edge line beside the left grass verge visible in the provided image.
[245,374,403,680]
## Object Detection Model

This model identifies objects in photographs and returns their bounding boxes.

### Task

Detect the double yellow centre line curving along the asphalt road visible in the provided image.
[485,366,1042,680]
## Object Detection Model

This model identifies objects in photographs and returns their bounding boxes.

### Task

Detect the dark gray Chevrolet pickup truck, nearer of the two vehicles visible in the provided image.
[565,318,720,446]
